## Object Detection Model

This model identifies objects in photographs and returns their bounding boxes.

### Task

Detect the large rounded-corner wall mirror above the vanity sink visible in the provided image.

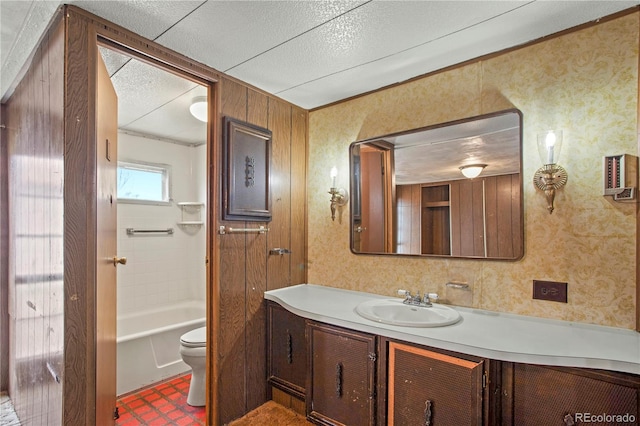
[349,109,524,260]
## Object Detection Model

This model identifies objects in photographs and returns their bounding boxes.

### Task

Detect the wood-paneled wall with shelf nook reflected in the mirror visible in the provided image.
[396,174,522,259]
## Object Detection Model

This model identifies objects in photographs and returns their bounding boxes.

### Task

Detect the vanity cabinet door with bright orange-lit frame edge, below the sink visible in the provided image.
[387,342,484,426]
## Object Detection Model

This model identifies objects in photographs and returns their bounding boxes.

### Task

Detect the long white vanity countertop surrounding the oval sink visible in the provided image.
[264,284,640,374]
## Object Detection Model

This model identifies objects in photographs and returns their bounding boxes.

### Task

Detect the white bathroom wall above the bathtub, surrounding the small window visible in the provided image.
[118,133,206,315]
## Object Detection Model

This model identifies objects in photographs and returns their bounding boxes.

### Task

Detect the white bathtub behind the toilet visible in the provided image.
[116,301,206,395]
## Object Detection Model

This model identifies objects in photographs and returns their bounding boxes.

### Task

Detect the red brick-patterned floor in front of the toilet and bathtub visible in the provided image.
[116,374,205,426]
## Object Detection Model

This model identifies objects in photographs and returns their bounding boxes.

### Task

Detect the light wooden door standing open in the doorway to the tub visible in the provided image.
[96,50,118,425]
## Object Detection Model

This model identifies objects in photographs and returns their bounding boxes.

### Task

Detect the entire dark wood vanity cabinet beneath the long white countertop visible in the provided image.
[267,302,640,426]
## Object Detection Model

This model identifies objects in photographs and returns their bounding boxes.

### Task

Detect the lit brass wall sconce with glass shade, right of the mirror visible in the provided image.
[533,130,569,214]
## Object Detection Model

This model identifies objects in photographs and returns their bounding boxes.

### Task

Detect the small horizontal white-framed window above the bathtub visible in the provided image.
[118,161,171,204]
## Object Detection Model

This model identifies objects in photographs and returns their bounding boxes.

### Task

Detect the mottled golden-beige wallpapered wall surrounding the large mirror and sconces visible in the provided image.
[308,12,639,329]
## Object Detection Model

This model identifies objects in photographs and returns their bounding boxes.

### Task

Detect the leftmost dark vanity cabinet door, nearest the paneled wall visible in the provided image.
[267,303,307,399]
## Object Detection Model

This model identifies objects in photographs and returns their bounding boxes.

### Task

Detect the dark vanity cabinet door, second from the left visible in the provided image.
[307,323,376,426]
